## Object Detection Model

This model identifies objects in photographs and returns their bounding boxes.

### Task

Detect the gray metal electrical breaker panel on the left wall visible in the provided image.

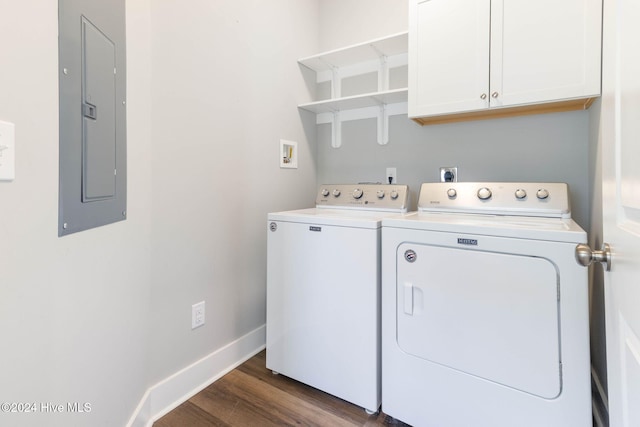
[58,0,127,236]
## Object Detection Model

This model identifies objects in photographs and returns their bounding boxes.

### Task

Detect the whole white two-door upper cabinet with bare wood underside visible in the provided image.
[408,0,602,124]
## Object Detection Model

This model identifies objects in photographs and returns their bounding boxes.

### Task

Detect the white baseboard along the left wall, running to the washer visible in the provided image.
[127,325,266,427]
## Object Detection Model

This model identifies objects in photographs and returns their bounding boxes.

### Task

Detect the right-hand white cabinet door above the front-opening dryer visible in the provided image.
[490,0,602,107]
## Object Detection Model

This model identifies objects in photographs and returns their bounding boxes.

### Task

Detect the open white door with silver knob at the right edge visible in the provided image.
[600,0,640,427]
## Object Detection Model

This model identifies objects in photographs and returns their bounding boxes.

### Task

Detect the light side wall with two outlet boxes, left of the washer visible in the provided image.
[149,0,318,382]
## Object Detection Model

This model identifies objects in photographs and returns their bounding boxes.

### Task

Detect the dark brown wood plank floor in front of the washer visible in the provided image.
[153,351,408,427]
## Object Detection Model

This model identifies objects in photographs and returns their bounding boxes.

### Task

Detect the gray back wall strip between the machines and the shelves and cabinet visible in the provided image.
[318,111,589,229]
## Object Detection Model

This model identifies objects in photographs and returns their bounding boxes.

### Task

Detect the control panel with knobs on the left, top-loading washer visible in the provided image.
[316,184,409,213]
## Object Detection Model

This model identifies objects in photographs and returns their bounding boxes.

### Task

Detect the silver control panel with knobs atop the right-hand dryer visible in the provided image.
[418,182,571,218]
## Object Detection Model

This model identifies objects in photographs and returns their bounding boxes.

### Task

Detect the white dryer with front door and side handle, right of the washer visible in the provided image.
[382,182,592,427]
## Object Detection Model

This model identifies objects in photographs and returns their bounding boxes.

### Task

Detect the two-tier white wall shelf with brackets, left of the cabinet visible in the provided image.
[298,32,408,148]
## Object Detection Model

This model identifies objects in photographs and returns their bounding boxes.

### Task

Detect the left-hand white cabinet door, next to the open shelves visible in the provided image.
[408,0,492,117]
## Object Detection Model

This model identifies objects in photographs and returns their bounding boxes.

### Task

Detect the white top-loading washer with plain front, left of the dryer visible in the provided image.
[267,184,409,412]
